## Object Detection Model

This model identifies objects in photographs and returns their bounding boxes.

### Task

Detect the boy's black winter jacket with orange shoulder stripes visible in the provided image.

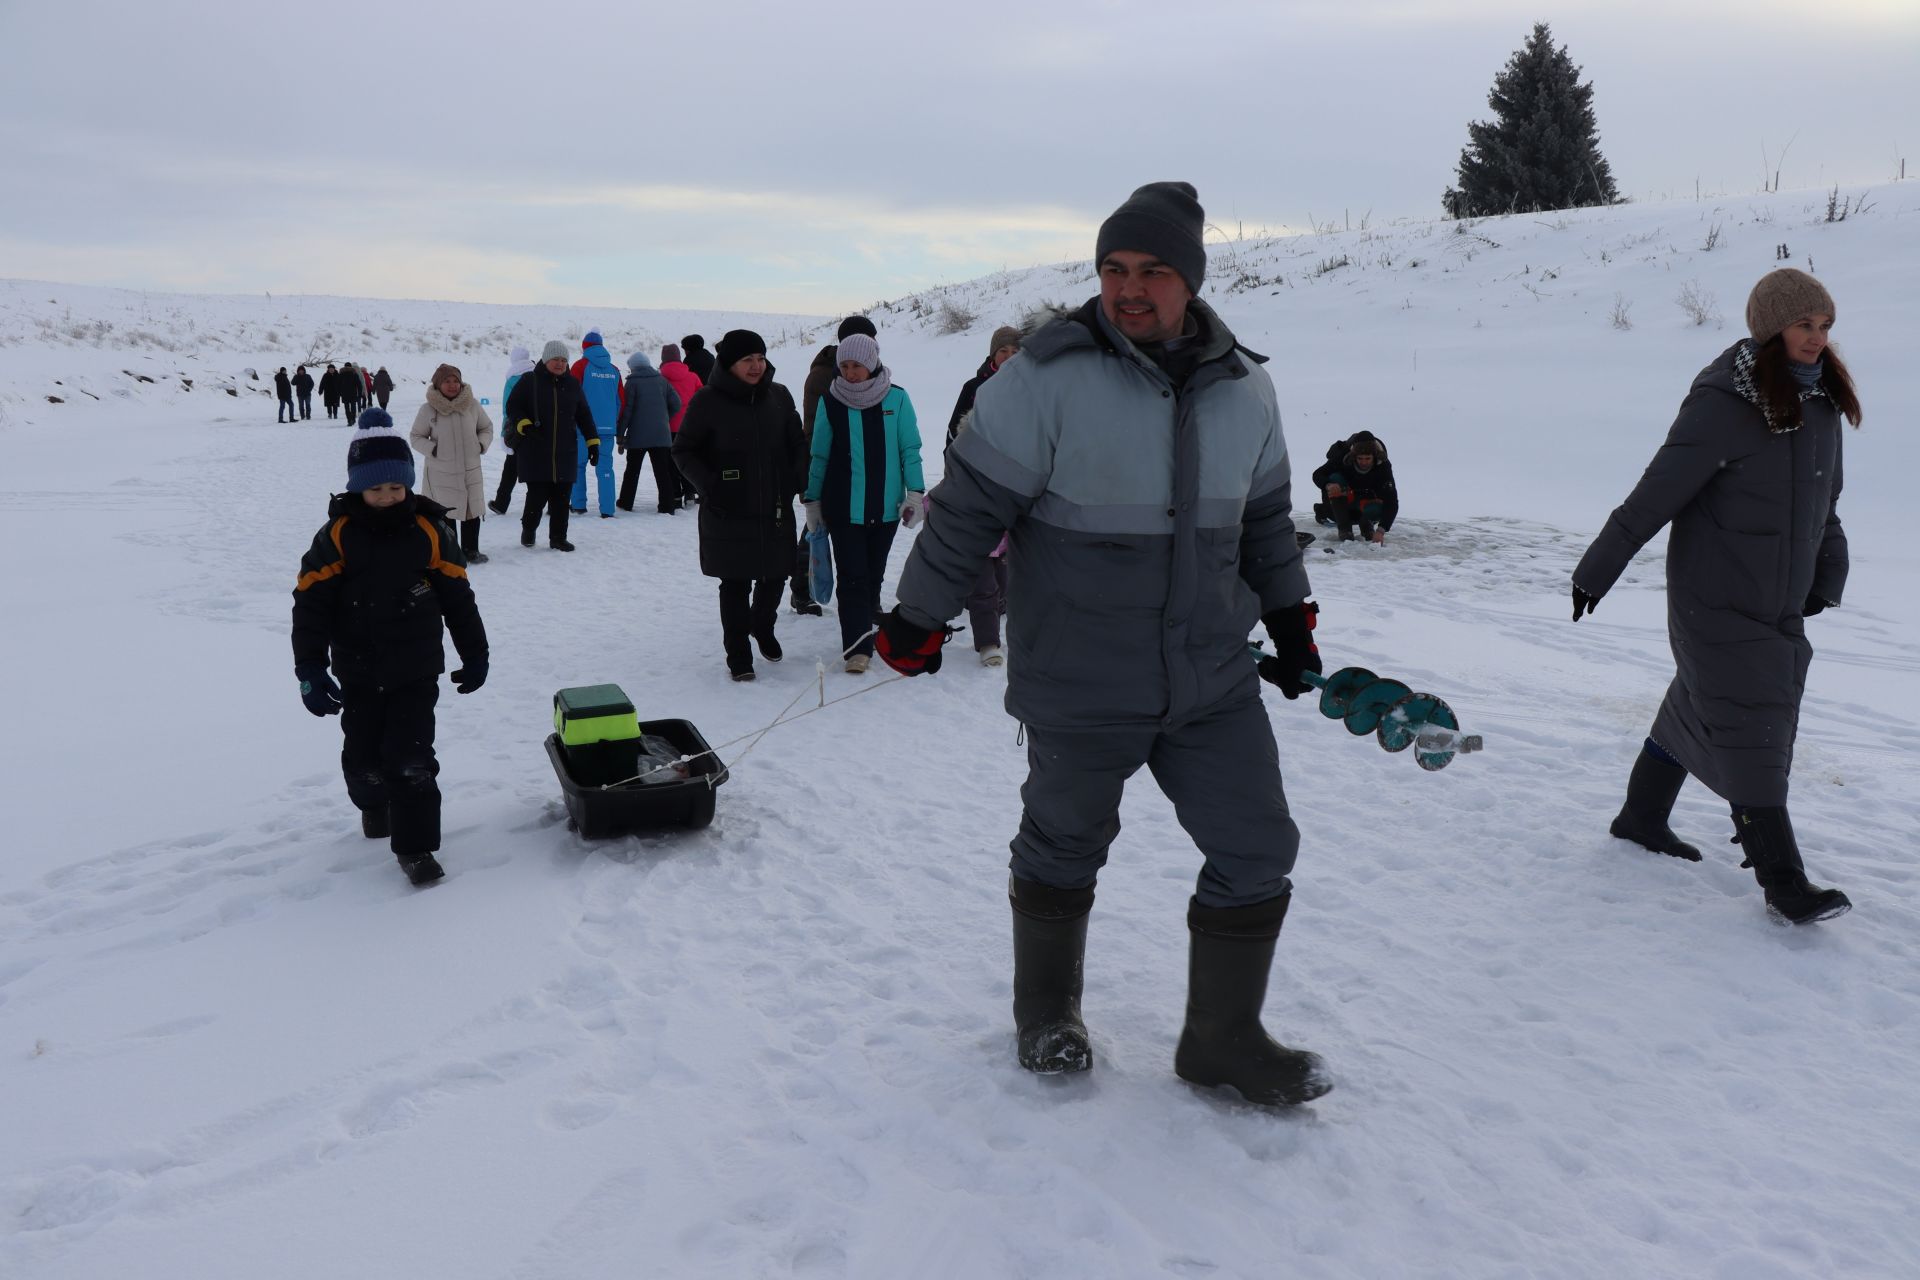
[294,493,488,689]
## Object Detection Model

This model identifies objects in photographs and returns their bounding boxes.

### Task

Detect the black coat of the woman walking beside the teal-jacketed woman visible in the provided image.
[674,365,808,581]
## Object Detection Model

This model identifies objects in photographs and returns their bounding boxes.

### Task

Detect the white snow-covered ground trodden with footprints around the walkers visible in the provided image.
[0,184,1920,1280]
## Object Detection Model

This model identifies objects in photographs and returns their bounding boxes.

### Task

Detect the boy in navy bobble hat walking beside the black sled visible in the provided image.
[294,409,488,885]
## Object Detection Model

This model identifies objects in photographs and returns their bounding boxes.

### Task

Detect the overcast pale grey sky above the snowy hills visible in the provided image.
[0,0,1920,313]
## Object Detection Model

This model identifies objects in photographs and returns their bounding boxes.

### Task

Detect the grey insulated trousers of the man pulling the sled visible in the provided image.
[1012,693,1300,908]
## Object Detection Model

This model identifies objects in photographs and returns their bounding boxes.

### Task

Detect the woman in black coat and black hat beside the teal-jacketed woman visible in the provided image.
[674,328,806,679]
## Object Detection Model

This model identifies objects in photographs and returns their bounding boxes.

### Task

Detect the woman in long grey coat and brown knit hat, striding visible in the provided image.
[1572,267,1860,925]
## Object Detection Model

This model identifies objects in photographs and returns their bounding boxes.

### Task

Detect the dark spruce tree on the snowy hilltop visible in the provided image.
[1442,23,1620,217]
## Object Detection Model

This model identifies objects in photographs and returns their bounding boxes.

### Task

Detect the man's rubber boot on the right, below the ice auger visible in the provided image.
[1173,892,1332,1107]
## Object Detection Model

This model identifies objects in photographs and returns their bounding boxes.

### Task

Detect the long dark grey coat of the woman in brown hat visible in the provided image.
[1572,340,1847,808]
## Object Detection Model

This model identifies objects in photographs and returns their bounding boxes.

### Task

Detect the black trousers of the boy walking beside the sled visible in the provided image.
[340,676,440,858]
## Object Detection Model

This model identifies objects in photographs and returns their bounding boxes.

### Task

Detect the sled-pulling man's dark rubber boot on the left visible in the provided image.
[1006,875,1092,1075]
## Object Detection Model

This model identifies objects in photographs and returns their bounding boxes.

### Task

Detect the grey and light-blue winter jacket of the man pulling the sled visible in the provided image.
[899,299,1308,727]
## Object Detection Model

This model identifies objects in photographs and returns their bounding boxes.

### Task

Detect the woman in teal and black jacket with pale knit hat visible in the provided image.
[806,334,927,676]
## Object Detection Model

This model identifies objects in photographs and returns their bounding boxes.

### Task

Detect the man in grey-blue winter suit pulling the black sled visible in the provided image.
[876,182,1331,1105]
